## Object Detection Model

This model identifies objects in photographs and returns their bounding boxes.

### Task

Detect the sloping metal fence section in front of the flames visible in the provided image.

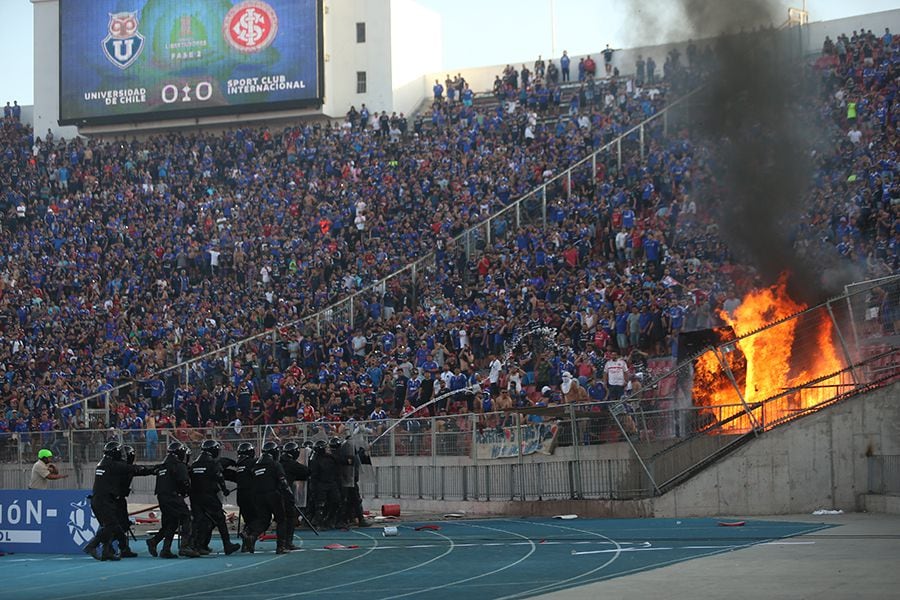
[628,276,900,492]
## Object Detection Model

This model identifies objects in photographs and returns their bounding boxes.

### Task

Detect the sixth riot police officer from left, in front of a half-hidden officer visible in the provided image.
[244,442,290,554]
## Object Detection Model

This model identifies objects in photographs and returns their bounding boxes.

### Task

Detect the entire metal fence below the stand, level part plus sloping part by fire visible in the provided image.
[10,290,900,500]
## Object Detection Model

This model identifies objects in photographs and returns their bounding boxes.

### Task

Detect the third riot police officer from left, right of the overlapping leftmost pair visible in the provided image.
[147,442,200,558]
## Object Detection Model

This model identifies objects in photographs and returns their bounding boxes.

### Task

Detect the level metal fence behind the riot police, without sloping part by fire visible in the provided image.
[0,402,729,500]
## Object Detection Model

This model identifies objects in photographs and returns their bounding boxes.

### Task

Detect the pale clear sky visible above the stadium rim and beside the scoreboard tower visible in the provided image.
[0,0,897,105]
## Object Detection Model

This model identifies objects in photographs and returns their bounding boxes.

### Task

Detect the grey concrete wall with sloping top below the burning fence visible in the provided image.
[653,384,900,517]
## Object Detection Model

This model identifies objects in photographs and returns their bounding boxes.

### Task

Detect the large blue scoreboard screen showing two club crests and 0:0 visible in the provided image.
[59,0,324,125]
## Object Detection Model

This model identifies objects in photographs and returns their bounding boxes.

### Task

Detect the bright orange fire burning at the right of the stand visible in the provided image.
[693,275,846,432]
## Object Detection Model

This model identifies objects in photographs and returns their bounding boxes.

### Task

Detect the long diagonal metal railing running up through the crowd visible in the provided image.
[60,85,700,423]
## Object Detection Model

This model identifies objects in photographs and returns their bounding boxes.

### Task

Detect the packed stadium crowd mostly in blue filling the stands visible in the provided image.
[0,32,900,450]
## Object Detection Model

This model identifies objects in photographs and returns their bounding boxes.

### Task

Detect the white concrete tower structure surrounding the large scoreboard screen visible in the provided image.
[31,0,442,137]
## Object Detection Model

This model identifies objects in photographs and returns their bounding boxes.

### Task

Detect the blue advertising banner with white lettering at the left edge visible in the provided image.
[0,490,100,554]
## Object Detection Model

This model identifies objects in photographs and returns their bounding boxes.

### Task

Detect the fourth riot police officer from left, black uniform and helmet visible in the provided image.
[190,440,241,554]
